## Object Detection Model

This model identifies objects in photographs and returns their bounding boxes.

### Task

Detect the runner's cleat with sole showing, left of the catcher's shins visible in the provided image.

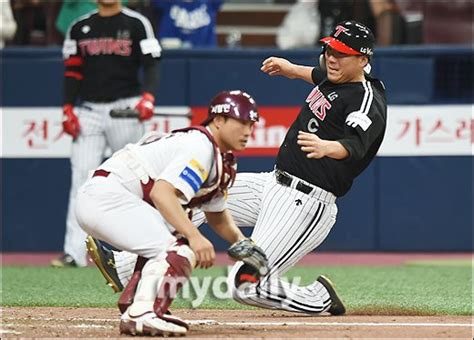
[86,235,123,293]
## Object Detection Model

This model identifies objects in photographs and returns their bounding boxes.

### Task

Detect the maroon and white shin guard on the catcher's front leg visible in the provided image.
[153,240,196,316]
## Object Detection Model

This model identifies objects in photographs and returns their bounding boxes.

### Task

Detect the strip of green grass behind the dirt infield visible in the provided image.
[1,264,473,315]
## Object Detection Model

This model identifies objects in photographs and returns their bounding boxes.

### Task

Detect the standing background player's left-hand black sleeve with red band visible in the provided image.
[62,25,84,104]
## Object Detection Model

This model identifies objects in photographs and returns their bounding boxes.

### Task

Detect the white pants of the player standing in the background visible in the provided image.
[64,97,144,266]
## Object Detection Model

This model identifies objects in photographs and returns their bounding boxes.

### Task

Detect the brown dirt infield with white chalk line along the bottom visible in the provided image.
[0,307,473,338]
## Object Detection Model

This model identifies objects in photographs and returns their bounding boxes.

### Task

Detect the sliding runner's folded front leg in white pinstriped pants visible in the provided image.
[228,175,337,313]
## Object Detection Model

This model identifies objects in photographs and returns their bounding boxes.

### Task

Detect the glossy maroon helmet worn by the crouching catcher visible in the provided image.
[201,90,259,125]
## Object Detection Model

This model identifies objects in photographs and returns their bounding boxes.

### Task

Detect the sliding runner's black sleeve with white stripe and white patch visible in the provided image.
[338,83,386,160]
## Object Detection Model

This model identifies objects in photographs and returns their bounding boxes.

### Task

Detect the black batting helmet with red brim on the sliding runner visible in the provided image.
[320,21,375,57]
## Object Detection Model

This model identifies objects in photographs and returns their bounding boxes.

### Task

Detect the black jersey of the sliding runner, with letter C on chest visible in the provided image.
[276,68,387,197]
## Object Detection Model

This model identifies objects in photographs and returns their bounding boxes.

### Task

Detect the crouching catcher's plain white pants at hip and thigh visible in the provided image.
[76,174,176,259]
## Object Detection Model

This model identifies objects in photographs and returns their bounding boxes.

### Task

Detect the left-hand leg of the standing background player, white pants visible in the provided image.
[60,105,105,266]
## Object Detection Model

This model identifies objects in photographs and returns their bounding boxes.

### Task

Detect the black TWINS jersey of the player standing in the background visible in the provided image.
[63,8,161,102]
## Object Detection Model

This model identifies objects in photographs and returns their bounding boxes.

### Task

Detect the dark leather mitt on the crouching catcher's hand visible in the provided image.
[227,238,268,276]
